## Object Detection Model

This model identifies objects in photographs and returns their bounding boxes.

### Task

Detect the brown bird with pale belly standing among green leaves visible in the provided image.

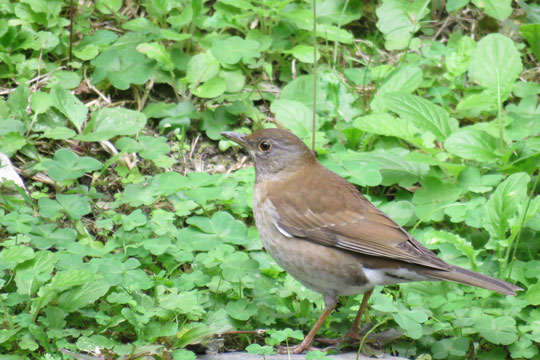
[221,128,522,353]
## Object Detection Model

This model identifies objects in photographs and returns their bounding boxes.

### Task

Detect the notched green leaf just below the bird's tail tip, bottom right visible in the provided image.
[473,315,518,345]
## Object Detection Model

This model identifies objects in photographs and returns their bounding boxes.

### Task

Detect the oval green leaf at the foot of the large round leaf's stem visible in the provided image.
[444,128,499,162]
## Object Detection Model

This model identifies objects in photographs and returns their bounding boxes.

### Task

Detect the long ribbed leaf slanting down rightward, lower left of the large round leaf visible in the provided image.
[384,93,458,141]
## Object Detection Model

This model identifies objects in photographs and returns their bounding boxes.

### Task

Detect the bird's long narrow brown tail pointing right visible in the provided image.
[421,266,523,295]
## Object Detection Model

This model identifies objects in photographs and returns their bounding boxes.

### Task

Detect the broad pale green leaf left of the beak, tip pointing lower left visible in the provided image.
[77,108,147,141]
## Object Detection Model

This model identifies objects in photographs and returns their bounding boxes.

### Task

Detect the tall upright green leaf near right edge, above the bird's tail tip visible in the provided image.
[484,173,530,240]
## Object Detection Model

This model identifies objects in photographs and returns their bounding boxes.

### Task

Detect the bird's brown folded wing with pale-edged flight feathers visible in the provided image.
[270,181,451,270]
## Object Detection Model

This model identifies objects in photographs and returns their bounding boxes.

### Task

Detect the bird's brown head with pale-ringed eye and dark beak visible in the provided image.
[221,129,316,181]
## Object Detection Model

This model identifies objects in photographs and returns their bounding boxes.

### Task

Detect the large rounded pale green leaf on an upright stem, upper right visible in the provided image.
[469,34,523,101]
